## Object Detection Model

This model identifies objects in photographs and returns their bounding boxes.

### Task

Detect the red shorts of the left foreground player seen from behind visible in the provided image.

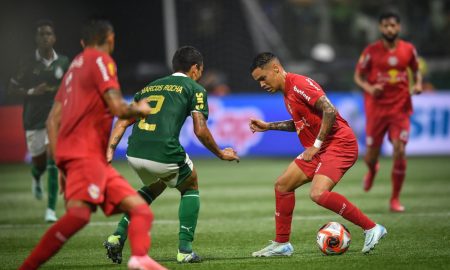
[59,159,137,216]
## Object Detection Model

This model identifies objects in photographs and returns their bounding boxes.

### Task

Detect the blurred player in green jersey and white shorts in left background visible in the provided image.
[9,20,69,222]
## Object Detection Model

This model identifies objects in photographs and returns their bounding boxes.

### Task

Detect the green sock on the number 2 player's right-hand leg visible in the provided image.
[178,190,200,253]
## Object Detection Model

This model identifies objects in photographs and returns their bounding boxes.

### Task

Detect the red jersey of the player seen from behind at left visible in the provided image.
[55,48,119,163]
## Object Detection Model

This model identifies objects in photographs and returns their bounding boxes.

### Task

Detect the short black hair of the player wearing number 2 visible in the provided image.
[172,46,203,72]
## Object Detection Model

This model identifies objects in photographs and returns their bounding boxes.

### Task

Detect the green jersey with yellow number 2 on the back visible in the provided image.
[127,73,208,164]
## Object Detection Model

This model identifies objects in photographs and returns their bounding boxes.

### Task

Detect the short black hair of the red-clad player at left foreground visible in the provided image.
[81,19,114,45]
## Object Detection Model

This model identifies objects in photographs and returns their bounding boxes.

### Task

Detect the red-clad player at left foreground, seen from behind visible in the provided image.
[20,20,165,269]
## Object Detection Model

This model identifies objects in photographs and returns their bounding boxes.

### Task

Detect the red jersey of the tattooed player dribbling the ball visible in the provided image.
[284,73,356,150]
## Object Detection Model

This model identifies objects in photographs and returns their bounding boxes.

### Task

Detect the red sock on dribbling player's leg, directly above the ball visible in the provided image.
[317,190,375,230]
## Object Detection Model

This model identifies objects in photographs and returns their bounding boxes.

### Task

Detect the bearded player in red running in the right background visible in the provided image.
[354,12,422,212]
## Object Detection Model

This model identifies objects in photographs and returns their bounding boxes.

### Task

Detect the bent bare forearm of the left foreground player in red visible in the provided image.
[103,88,151,119]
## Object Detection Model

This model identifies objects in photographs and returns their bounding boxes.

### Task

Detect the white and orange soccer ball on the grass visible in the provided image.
[317,222,351,255]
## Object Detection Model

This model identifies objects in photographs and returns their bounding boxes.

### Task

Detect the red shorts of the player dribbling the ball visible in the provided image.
[295,139,358,183]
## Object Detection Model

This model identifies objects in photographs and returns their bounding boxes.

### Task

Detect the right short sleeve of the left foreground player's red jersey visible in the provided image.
[93,55,120,95]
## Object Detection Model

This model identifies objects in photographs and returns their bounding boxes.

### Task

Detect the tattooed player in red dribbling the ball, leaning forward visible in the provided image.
[249,52,387,257]
